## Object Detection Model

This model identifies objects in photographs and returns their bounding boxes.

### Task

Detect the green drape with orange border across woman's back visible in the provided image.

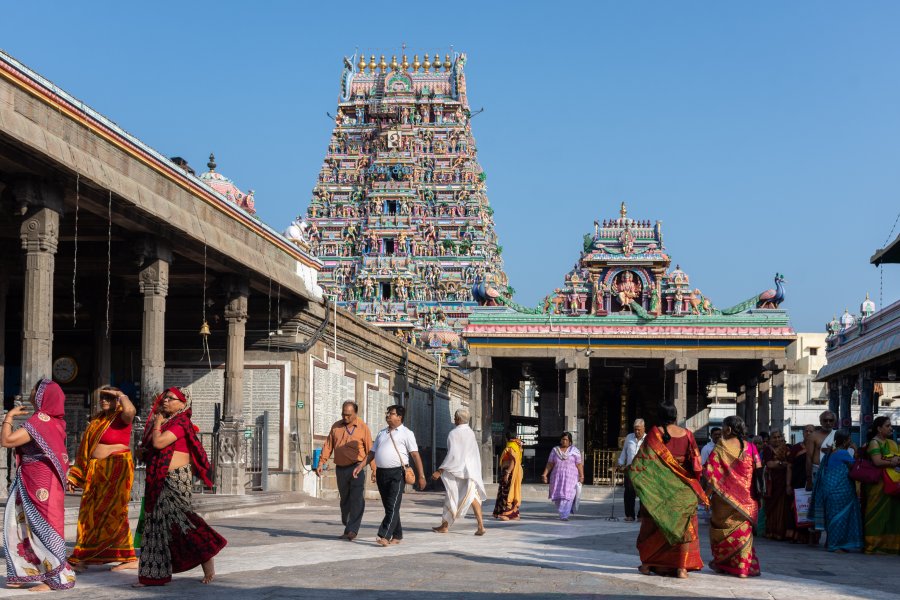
[628,427,709,545]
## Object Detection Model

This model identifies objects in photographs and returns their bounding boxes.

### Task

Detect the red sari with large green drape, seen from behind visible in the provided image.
[628,427,709,572]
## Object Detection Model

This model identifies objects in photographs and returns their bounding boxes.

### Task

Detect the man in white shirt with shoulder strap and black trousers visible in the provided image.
[353,404,425,546]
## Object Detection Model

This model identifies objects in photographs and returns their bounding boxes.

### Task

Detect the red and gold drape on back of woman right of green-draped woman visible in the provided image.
[703,438,761,525]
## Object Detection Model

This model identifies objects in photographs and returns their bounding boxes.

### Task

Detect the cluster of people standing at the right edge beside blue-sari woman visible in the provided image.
[760,411,900,554]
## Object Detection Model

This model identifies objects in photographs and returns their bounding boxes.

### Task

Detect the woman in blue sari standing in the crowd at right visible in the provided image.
[814,430,863,552]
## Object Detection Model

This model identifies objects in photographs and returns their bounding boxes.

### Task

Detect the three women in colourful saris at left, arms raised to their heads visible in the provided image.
[0,379,226,591]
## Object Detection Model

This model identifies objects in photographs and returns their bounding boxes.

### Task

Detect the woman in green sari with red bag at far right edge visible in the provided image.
[863,416,900,554]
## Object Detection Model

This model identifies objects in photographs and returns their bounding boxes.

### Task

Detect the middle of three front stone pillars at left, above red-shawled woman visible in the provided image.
[138,247,171,412]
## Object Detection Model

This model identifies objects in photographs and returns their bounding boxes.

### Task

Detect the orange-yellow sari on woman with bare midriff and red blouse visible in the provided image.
[68,406,137,565]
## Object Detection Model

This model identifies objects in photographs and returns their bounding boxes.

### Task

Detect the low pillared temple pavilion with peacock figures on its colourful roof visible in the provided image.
[463,203,796,477]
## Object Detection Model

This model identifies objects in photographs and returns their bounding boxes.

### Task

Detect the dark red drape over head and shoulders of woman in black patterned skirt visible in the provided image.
[143,388,213,513]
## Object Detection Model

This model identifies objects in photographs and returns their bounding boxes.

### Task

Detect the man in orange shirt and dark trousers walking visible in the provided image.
[316,402,375,542]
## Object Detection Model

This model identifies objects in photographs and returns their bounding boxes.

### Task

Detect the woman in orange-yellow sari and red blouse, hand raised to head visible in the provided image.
[67,386,138,571]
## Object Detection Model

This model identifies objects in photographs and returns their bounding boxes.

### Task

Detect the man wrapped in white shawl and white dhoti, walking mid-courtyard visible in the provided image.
[431,408,487,535]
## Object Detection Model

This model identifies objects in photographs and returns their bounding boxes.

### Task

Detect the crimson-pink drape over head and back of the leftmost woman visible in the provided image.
[17,379,69,487]
